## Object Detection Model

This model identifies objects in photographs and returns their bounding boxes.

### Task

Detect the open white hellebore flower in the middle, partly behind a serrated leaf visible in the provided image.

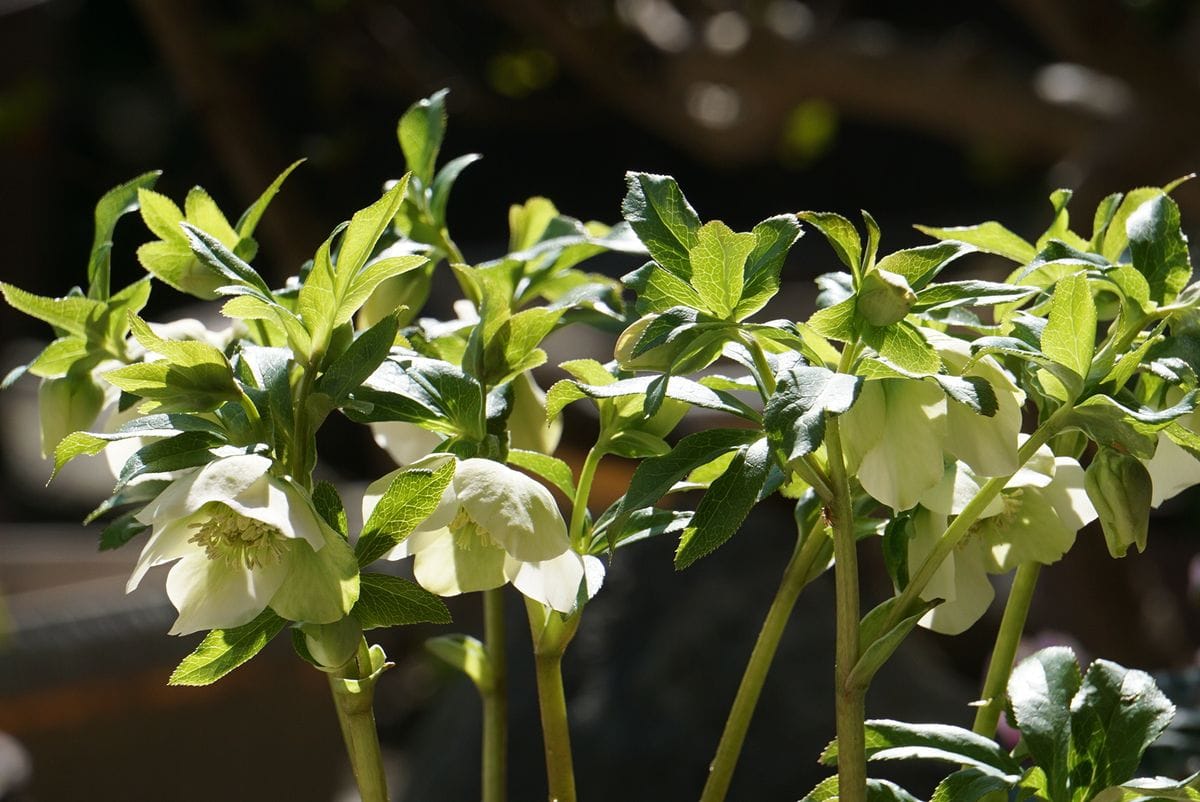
[362,456,604,612]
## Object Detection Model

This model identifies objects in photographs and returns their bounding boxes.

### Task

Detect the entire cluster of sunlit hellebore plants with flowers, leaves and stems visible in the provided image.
[0,92,1200,802]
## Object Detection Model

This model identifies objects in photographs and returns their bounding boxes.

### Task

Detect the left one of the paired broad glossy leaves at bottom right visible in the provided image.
[1008,646,1082,800]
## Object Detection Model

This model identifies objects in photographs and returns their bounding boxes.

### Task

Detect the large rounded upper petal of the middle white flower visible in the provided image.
[452,459,570,562]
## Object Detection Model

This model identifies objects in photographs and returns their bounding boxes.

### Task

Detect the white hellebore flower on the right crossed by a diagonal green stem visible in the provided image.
[908,445,1097,635]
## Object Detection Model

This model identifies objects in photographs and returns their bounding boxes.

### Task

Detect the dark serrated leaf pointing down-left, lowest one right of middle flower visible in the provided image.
[674,437,773,570]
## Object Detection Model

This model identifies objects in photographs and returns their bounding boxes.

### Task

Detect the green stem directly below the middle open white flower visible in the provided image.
[526,599,580,802]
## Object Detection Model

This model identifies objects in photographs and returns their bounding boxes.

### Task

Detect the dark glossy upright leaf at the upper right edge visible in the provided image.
[1126,194,1192,304]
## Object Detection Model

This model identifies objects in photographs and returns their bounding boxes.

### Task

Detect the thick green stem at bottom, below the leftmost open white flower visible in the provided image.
[329,640,388,802]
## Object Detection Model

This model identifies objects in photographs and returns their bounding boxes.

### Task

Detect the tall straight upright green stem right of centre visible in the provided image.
[826,415,866,802]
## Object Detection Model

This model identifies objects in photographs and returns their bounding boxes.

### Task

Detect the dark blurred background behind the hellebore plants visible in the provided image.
[0,0,1200,802]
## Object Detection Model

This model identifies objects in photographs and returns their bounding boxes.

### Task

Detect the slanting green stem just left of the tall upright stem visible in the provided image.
[700,519,826,802]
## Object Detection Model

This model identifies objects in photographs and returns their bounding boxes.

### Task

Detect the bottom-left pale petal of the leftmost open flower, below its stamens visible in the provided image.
[167,550,287,635]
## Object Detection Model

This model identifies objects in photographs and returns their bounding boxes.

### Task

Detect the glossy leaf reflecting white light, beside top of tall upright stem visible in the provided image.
[763,365,863,461]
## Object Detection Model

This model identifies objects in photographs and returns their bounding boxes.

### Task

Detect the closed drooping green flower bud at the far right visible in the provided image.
[1084,447,1152,557]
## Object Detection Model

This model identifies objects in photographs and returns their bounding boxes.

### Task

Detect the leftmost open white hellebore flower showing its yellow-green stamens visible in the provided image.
[125,454,359,635]
